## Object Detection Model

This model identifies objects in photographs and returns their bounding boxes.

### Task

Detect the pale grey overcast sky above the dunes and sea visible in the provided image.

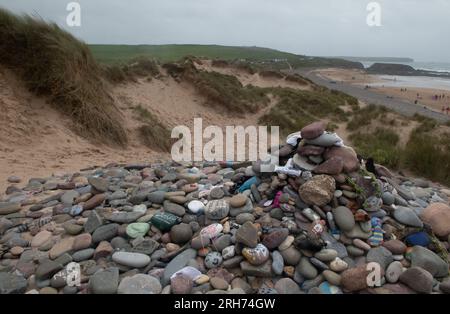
[0,0,450,62]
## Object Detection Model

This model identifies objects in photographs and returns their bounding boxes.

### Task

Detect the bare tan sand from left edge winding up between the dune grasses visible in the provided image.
[0,64,290,195]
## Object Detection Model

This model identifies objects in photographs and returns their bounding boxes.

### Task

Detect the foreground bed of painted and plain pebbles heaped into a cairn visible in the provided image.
[0,122,450,294]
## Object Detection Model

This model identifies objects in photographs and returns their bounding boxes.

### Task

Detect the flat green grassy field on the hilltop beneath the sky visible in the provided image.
[89,45,359,69]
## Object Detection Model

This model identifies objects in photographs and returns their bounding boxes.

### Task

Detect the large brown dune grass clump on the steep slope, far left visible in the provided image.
[0,9,127,145]
